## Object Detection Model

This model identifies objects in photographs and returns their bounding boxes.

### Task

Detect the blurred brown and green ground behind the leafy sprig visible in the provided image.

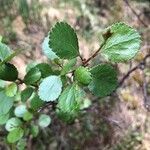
[0,0,150,150]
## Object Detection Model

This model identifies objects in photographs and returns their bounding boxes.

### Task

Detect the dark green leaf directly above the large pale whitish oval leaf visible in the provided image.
[36,63,54,78]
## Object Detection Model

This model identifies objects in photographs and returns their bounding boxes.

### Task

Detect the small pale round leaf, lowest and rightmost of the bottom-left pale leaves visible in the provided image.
[38,114,51,128]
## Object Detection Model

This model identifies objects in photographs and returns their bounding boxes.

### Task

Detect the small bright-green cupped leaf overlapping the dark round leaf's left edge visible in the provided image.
[75,66,92,85]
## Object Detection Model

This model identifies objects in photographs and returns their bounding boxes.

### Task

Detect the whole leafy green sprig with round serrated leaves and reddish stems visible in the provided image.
[0,22,141,145]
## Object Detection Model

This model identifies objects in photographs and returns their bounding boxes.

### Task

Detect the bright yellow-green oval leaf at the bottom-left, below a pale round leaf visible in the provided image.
[7,128,24,143]
